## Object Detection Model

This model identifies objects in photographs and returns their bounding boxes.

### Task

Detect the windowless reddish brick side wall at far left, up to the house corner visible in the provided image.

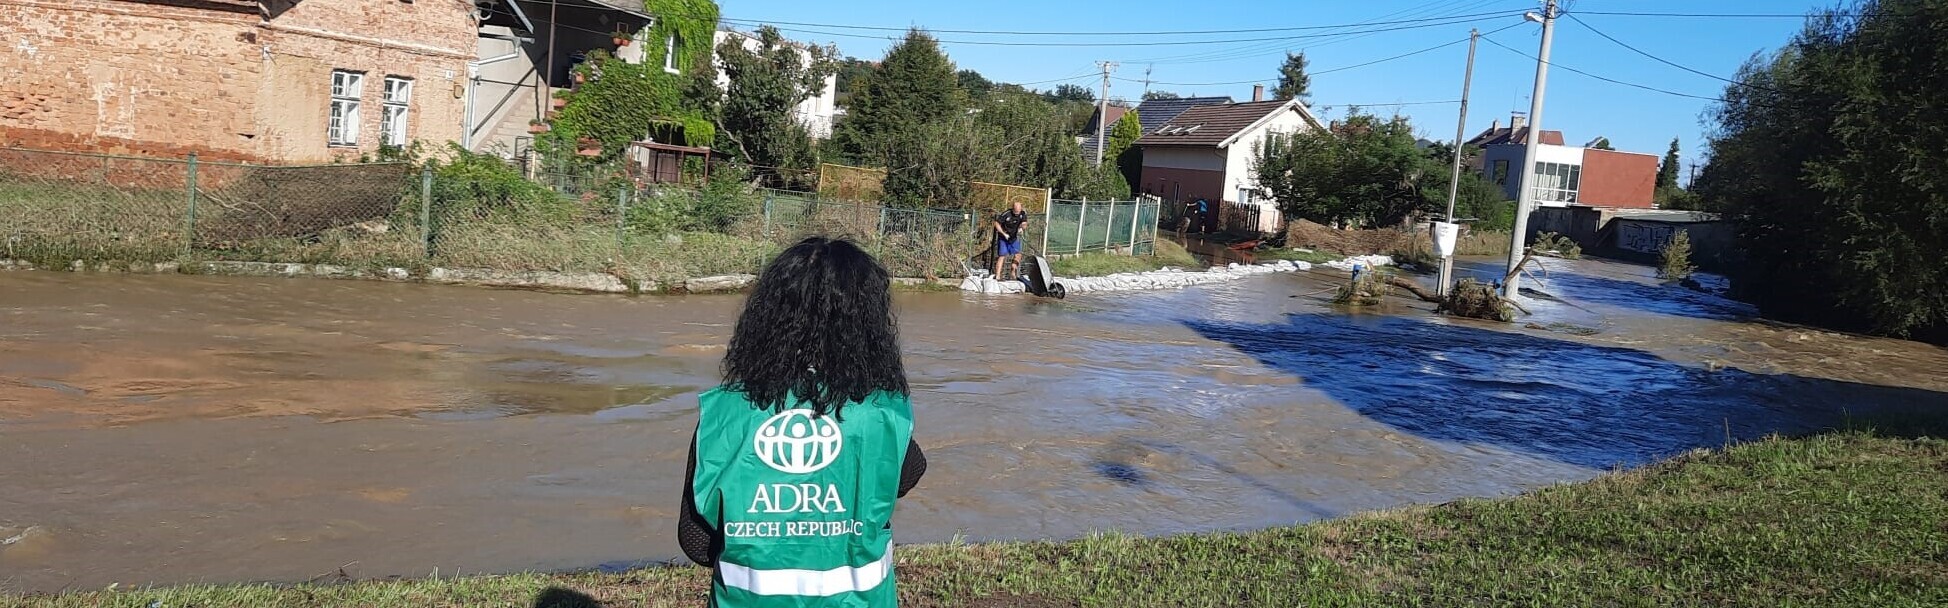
[0,0,259,160]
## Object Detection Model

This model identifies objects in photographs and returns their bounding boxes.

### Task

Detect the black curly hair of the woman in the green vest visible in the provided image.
[723,236,908,417]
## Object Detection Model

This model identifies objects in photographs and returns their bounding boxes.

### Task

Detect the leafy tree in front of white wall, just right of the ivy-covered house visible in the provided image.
[717,25,838,185]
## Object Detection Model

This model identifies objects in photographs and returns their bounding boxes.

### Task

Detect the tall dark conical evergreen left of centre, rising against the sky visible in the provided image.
[834,29,966,207]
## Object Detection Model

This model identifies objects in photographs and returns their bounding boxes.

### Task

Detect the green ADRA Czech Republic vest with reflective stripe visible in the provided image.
[690,388,914,606]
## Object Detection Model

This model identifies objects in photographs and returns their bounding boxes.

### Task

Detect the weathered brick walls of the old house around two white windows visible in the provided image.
[0,0,475,162]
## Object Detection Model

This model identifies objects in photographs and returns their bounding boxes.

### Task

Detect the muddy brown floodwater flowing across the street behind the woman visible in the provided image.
[0,261,1948,592]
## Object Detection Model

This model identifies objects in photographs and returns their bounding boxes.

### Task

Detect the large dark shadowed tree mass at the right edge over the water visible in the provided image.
[1693,0,1948,341]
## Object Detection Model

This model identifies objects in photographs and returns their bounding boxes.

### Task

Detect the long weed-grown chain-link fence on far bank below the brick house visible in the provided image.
[0,148,986,279]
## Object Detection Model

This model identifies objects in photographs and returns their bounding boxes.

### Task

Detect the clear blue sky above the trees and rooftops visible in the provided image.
[721,0,1833,173]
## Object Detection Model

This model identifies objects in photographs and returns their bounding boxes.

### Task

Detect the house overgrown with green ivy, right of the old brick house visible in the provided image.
[462,0,836,171]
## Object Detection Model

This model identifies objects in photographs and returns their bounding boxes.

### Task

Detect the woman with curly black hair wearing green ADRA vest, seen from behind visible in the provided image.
[678,238,927,606]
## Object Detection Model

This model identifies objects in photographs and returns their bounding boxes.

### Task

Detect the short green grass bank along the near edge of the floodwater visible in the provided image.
[18,431,1948,608]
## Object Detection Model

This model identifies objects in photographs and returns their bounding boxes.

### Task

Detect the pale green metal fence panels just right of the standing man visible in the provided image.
[1030,197,1163,255]
